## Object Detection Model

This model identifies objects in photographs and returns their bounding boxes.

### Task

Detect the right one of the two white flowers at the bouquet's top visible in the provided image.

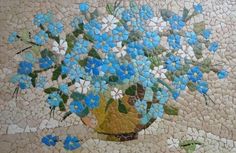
[147,17,167,32]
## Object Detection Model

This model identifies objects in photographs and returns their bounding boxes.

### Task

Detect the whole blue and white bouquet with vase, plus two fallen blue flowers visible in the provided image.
[8,0,228,150]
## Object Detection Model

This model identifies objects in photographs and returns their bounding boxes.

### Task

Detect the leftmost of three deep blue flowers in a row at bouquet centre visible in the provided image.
[85,58,102,75]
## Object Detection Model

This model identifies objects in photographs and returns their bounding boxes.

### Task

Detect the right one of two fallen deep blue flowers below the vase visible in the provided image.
[64,135,81,151]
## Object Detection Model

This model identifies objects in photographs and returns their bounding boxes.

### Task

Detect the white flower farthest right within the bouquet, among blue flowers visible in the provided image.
[176,45,195,59]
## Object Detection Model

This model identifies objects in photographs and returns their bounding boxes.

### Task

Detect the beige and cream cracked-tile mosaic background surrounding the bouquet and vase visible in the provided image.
[0,0,236,153]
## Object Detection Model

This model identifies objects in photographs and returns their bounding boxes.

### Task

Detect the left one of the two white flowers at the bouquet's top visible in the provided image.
[102,15,119,32]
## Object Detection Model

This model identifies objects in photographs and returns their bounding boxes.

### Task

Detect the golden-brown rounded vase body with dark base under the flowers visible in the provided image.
[82,95,153,141]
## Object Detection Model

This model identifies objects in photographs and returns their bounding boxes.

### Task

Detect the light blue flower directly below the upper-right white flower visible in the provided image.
[143,32,161,49]
